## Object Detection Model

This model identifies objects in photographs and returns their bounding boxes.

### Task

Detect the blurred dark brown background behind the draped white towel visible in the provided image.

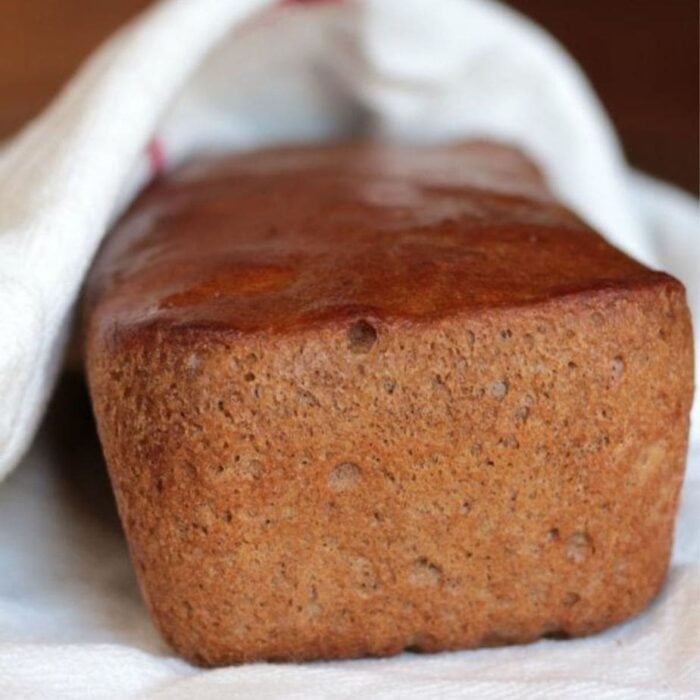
[0,0,700,193]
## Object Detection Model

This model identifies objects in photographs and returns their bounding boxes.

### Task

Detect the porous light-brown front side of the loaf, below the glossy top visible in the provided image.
[87,280,692,665]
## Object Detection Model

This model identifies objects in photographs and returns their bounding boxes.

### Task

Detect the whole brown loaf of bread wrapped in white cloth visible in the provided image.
[85,142,692,665]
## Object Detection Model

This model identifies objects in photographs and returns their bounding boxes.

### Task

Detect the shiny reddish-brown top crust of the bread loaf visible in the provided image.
[87,141,678,344]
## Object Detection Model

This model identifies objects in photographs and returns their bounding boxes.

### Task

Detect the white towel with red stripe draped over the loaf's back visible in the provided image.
[0,0,700,478]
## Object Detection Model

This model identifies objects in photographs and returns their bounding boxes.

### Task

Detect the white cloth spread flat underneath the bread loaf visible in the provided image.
[0,396,700,700]
